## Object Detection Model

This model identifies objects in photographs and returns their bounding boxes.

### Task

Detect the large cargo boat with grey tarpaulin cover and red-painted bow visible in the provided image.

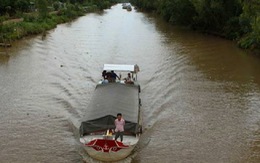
[79,64,142,162]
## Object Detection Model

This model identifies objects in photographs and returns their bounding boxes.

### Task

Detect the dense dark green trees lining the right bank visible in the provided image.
[131,0,260,49]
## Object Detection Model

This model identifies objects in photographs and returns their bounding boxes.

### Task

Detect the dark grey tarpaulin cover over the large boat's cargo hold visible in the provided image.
[80,83,140,135]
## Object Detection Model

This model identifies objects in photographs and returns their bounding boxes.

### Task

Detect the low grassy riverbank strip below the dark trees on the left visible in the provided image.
[0,1,114,45]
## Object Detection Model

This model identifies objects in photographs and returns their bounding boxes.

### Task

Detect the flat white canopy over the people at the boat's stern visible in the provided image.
[103,64,140,74]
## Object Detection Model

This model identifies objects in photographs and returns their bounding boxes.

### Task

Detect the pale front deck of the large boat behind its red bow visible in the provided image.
[80,135,139,146]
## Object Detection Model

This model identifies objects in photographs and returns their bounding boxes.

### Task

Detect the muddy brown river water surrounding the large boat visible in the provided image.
[0,4,260,163]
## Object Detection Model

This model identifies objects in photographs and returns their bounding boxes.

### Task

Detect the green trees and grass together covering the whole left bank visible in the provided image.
[0,0,116,42]
